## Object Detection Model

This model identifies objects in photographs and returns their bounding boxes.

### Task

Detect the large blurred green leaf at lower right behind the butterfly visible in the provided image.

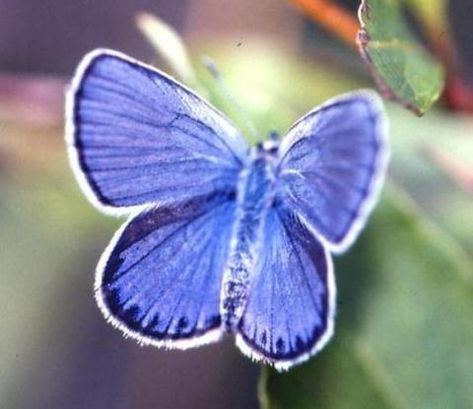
[260,187,473,409]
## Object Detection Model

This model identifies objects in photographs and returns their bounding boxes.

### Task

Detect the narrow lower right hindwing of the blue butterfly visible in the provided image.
[237,206,335,370]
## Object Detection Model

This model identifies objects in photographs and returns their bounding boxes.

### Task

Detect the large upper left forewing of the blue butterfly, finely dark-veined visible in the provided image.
[66,50,247,213]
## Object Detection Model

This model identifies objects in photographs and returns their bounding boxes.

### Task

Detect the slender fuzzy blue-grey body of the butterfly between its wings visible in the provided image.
[221,144,277,330]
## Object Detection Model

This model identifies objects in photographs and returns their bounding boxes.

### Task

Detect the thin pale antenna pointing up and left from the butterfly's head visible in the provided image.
[202,55,258,142]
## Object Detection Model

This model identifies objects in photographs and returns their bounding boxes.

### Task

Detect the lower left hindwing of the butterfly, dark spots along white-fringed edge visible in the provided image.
[95,194,235,348]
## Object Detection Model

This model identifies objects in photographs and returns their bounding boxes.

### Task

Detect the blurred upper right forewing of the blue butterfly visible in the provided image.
[279,91,388,252]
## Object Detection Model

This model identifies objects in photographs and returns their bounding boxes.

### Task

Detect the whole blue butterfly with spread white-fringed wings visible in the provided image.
[66,49,388,370]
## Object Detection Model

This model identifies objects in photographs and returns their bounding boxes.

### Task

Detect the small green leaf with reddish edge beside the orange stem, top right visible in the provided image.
[358,0,444,115]
